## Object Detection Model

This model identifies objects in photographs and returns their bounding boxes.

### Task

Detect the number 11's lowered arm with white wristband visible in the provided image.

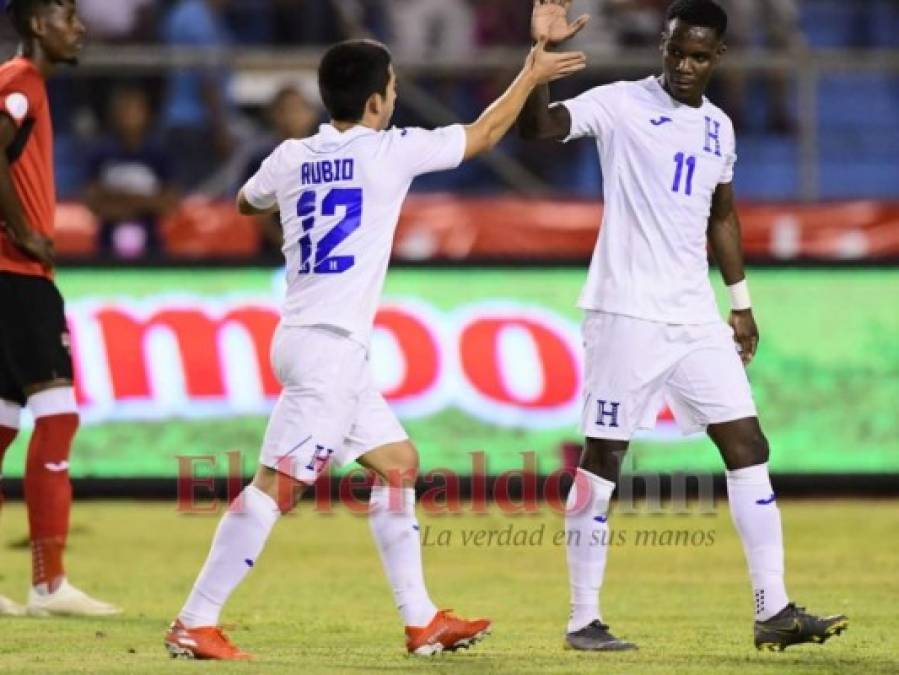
[708,183,759,364]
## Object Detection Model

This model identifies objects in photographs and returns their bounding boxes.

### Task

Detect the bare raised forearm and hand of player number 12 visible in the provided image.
[465,39,587,159]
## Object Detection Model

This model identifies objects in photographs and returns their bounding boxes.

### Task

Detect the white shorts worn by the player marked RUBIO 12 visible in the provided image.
[260,325,408,483]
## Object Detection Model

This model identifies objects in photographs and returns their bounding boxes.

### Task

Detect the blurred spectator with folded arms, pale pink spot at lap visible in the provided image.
[86,88,177,259]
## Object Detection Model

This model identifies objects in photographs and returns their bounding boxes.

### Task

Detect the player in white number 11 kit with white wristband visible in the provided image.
[519,0,847,650]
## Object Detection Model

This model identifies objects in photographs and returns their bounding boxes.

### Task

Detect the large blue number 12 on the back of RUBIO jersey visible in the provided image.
[297,188,362,274]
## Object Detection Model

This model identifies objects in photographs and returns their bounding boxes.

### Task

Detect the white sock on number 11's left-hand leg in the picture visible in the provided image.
[565,469,615,633]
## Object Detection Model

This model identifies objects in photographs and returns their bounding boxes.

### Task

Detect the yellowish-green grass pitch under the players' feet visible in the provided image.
[0,500,899,675]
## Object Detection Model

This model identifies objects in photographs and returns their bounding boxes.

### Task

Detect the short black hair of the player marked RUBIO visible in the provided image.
[318,40,392,122]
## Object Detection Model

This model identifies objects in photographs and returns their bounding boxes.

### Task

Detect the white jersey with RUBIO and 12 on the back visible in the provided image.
[244,124,466,344]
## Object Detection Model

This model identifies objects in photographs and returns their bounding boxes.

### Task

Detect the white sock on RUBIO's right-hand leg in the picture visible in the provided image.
[368,485,437,626]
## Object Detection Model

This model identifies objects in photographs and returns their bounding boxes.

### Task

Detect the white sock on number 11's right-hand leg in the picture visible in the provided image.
[726,464,789,621]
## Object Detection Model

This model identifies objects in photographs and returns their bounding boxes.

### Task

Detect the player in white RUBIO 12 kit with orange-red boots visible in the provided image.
[165,41,585,659]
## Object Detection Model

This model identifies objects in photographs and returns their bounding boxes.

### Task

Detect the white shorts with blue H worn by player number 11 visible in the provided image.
[581,312,757,441]
